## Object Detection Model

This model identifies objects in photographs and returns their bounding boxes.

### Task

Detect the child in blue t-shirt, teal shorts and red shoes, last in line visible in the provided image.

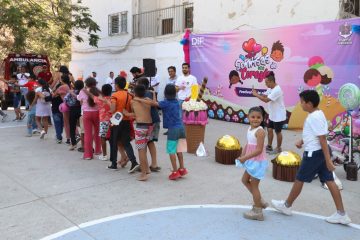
[134,84,188,180]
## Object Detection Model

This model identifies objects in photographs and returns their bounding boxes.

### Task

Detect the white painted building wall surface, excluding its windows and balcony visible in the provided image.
[70,0,339,98]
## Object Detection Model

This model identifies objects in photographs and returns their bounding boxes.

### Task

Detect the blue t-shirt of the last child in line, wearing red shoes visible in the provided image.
[159,99,182,128]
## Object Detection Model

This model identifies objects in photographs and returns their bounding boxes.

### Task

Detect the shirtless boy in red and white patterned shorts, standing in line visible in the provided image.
[124,84,152,181]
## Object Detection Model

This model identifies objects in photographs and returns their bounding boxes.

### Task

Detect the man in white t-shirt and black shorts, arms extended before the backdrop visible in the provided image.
[252,71,286,154]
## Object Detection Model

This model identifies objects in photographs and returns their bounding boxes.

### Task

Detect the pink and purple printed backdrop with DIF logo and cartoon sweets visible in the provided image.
[190,18,360,129]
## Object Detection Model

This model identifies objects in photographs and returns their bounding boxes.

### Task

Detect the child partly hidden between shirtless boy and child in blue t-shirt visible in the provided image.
[137,77,161,172]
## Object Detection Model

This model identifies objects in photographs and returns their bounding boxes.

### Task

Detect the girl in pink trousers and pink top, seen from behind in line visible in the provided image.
[77,77,101,160]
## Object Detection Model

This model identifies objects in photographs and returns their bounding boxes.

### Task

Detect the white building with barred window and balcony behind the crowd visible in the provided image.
[70,0,360,98]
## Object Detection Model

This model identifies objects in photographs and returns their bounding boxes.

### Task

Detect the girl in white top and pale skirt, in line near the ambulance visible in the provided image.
[30,79,52,139]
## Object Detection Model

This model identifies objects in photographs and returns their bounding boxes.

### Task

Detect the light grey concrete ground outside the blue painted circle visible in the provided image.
[0,111,360,239]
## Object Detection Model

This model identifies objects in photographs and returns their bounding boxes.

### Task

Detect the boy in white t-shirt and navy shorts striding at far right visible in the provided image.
[271,90,351,224]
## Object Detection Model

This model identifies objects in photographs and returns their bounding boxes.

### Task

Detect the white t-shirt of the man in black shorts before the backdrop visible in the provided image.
[265,85,286,122]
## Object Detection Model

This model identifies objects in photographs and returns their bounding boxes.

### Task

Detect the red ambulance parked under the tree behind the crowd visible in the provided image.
[0,53,50,110]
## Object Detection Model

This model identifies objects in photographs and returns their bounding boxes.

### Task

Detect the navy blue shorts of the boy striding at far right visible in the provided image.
[296,149,334,183]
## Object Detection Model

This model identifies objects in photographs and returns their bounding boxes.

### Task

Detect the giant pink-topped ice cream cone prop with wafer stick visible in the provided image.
[182,78,208,153]
